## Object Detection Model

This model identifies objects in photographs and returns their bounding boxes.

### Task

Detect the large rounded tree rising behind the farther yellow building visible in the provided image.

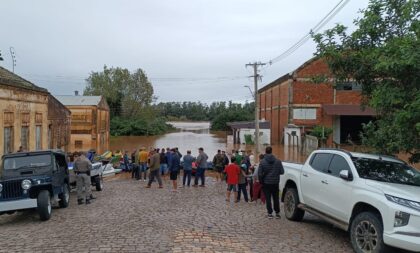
[84,66,155,117]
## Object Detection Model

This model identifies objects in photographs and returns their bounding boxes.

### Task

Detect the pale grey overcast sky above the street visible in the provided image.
[0,0,368,103]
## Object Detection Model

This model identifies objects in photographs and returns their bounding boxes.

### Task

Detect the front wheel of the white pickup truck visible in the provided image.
[350,212,388,253]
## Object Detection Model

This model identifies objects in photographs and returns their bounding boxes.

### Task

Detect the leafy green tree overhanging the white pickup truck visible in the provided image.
[313,0,420,162]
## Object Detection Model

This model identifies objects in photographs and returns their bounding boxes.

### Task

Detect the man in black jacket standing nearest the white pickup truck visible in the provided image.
[258,147,284,219]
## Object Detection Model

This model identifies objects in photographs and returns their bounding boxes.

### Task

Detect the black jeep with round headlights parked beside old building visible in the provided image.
[0,150,70,221]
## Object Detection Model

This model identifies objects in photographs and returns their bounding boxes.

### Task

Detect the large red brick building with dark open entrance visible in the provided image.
[258,58,375,144]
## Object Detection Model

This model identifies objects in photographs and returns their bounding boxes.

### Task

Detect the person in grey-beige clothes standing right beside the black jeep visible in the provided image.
[73,152,95,205]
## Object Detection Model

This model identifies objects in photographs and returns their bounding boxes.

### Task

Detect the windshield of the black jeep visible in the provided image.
[3,155,51,170]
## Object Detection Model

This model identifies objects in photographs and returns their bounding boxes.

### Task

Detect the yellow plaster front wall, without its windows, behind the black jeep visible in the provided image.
[0,84,48,156]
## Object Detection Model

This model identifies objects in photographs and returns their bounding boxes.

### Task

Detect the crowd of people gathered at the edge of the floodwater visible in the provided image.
[123,147,284,218]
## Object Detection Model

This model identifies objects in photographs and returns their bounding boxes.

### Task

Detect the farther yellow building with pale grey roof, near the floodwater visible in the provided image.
[55,96,110,153]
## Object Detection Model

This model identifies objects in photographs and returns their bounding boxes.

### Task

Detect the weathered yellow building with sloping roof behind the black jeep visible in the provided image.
[0,67,70,156]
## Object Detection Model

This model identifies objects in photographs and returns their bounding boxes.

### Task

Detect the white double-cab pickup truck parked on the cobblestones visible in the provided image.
[280,149,420,252]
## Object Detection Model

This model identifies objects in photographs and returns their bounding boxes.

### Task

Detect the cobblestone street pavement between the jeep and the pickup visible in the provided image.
[0,176,352,252]
